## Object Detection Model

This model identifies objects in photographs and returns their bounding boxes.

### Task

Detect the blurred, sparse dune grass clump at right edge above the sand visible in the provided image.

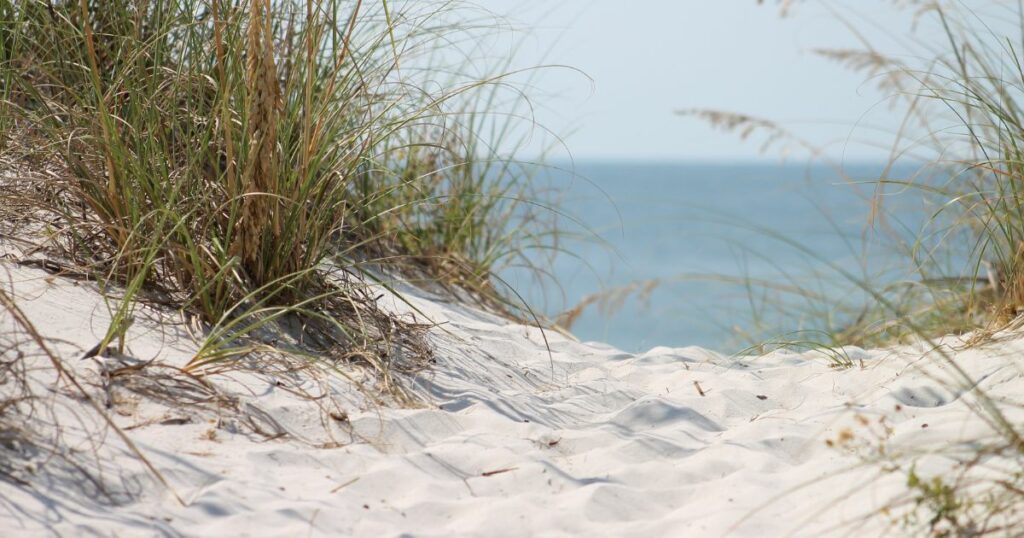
[782,1,1024,336]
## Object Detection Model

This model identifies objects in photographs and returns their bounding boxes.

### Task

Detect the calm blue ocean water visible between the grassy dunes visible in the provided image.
[506,161,925,351]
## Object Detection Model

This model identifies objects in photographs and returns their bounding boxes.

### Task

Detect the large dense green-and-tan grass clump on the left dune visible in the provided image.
[0,0,548,368]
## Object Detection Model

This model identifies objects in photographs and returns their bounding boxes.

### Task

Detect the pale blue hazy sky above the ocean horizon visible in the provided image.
[475,0,936,160]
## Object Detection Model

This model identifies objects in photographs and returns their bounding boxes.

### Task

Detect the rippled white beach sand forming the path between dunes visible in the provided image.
[0,264,1024,537]
